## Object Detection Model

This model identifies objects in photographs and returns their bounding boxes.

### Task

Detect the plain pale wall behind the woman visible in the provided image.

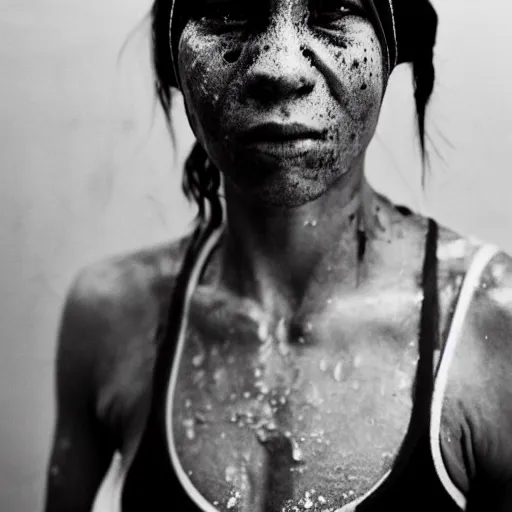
[0,0,512,512]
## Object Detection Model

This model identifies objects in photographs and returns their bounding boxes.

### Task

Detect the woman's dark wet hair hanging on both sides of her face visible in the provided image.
[151,0,438,222]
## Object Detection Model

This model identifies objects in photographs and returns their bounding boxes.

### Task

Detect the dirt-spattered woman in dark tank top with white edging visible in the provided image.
[42,0,512,512]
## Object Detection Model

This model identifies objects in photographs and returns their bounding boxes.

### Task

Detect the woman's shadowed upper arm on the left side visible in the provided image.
[46,274,118,512]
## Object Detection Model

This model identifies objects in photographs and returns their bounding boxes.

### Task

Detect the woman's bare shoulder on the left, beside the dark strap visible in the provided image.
[57,232,190,387]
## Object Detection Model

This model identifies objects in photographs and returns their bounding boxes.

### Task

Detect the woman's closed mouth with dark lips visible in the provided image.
[240,122,325,157]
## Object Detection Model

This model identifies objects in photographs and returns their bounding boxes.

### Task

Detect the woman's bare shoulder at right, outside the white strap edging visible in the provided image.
[443,242,512,481]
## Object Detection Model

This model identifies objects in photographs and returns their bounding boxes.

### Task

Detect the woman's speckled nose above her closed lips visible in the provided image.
[244,31,316,106]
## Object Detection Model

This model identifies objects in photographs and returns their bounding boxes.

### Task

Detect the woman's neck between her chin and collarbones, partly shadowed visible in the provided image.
[219,164,384,315]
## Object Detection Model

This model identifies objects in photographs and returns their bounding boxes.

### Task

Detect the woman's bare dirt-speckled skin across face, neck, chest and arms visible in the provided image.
[42,0,512,512]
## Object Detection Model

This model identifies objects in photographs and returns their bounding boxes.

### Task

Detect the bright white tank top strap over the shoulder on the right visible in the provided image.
[429,245,498,510]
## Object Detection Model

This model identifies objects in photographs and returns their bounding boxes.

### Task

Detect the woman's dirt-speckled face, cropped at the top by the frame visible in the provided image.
[178,0,385,207]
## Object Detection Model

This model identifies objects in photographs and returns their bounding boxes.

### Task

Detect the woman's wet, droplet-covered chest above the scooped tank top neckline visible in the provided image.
[168,295,420,510]
